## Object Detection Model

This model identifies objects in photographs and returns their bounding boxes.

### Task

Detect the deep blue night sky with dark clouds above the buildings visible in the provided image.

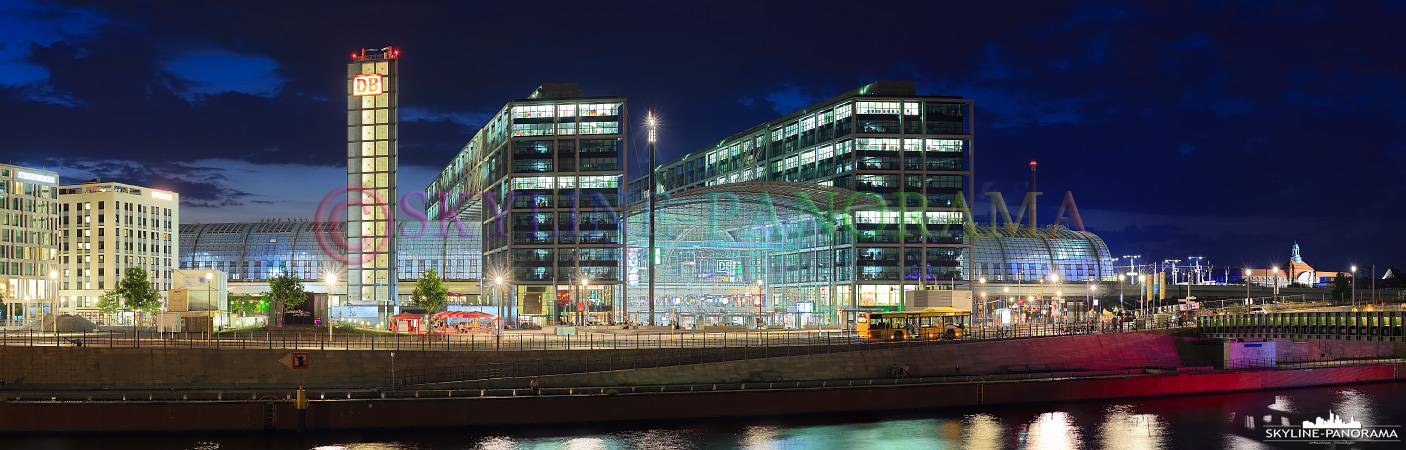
[0,1,1406,273]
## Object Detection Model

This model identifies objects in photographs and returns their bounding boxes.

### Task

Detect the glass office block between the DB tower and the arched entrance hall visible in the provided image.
[426,83,628,323]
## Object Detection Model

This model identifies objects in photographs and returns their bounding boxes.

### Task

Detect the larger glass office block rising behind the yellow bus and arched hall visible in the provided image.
[627,82,974,320]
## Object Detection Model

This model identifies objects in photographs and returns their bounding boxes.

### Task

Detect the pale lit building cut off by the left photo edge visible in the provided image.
[0,165,60,321]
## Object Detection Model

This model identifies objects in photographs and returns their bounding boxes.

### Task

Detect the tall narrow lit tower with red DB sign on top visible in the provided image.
[346,46,401,323]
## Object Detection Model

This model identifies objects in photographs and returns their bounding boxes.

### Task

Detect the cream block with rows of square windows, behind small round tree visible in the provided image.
[58,180,180,322]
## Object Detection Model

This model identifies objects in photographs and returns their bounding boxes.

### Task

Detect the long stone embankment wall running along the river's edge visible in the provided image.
[0,333,1403,390]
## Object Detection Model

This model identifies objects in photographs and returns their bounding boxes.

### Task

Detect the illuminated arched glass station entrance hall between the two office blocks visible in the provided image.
[626,181,877,328]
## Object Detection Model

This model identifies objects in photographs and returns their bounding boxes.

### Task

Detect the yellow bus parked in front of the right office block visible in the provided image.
[855,308,972,340]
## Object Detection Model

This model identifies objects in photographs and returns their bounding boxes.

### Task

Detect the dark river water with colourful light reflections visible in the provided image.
[0,383,1406,450]
